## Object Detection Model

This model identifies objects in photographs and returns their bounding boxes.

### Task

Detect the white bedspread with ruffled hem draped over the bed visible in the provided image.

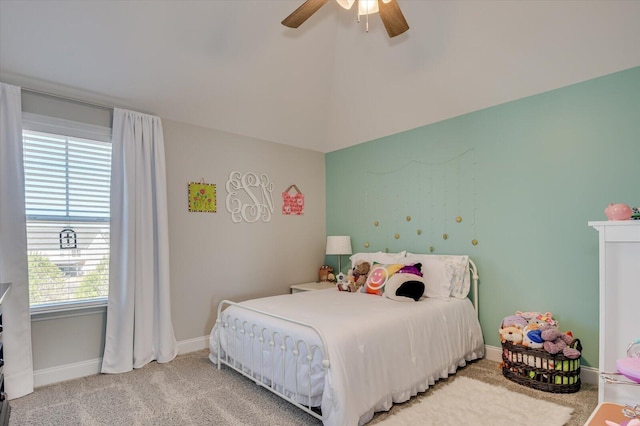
[211,289,484,426]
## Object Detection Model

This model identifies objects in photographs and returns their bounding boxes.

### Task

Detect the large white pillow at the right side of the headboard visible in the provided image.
[404,253,471,299]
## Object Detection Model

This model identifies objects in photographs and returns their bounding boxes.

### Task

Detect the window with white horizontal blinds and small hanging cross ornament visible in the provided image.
[22,115,111,311]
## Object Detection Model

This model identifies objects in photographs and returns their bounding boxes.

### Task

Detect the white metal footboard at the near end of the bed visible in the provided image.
[216,300,330,420]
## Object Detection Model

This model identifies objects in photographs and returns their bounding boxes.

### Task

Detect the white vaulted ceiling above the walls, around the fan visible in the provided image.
[0,0,640,152]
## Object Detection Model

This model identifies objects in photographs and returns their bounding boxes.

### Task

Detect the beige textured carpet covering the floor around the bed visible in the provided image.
[10,352,598,426]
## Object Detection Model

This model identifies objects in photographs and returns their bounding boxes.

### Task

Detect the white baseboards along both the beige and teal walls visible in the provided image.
[33,335,599,387]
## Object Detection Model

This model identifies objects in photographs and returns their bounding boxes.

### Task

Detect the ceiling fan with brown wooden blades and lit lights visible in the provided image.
[282,0,409,37]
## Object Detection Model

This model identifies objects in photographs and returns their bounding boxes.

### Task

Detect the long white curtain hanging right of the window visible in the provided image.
[102,108,177,373]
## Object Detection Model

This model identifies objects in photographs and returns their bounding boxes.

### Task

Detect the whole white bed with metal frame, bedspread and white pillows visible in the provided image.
[209,252,484,426]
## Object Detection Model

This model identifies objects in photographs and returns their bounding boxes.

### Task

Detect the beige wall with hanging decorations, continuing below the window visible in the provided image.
[32,116,326,373]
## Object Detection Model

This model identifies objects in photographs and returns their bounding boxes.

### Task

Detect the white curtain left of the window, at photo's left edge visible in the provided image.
[0,83,33,399]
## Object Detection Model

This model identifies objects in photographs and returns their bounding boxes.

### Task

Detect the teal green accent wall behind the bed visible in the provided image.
[326,67,640,367]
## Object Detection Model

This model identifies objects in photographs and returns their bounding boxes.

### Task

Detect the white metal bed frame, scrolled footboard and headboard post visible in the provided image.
[216,259,479,420]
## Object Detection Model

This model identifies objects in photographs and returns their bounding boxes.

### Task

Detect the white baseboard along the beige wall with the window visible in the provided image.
[33,335,209,387]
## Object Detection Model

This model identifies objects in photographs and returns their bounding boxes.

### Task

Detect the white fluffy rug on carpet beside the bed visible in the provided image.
[378,377,573,426]
